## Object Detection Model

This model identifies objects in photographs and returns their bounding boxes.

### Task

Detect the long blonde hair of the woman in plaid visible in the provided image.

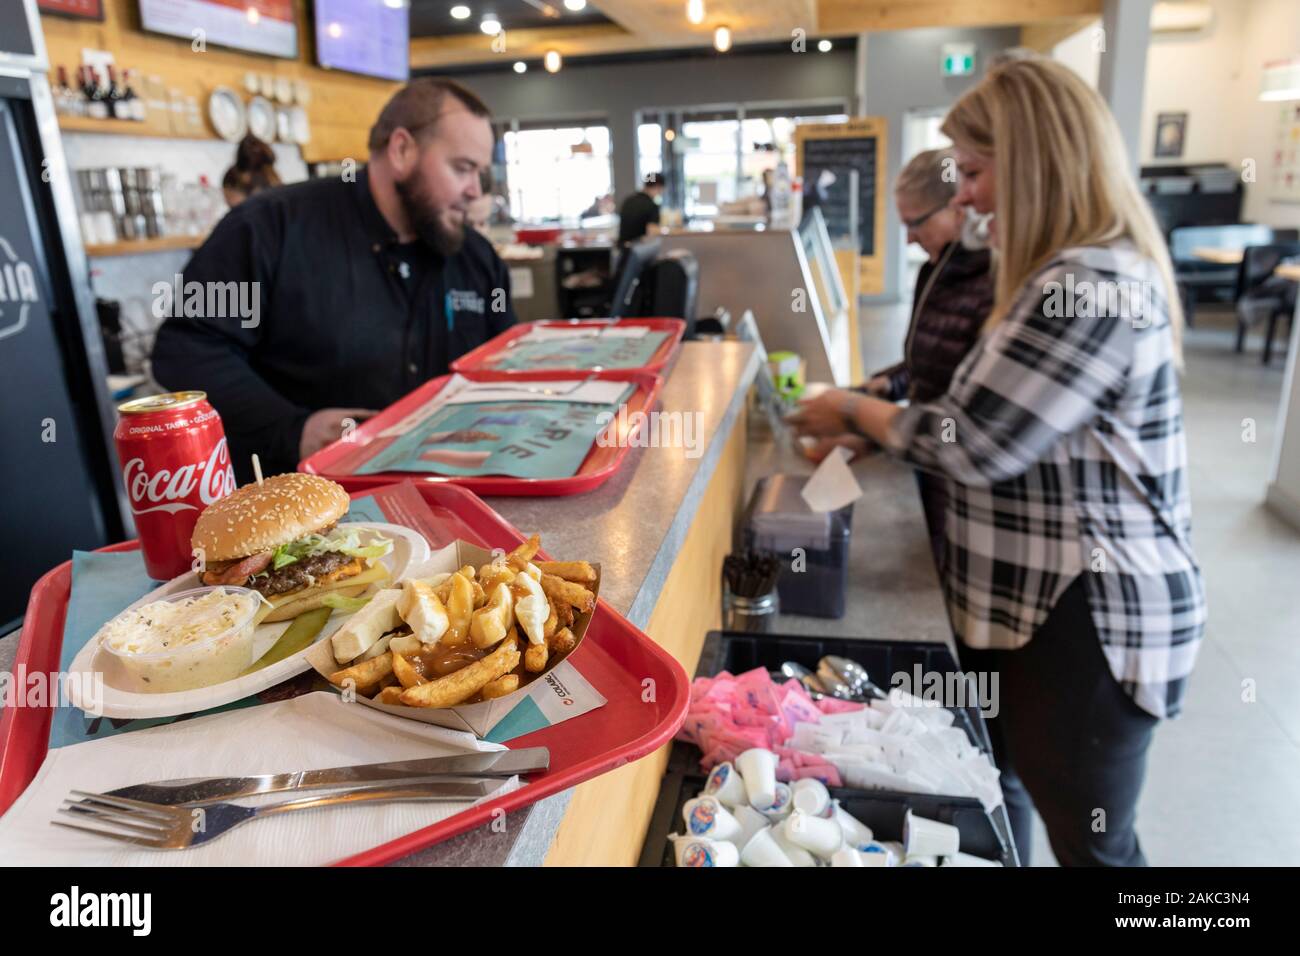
[943,57,1183,359]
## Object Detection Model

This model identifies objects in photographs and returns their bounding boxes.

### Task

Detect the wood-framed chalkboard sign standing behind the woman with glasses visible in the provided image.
[794,117,887,291]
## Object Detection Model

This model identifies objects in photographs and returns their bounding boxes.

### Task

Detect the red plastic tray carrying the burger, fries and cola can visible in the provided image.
[0,484,690,866]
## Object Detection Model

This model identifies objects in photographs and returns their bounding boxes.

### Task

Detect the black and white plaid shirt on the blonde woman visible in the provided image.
[888,242,1205,717]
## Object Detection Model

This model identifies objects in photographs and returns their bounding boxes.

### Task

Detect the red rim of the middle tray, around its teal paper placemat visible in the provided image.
[298,369,663,497]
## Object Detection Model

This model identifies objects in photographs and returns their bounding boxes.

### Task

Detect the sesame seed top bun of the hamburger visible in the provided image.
[190,472,350,562]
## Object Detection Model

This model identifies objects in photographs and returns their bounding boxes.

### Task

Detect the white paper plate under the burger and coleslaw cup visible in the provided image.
[68,522,430,718]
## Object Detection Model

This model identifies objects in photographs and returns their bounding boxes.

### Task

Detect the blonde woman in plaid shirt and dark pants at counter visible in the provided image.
[794,59,1205,866]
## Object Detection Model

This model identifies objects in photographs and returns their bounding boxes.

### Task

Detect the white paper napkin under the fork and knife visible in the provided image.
[0,692,519,866]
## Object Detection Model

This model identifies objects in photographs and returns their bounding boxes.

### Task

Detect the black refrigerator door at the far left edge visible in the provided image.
[0,99,112,633]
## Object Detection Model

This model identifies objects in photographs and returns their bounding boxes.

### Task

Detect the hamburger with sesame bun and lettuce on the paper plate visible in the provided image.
[190,473,393,622]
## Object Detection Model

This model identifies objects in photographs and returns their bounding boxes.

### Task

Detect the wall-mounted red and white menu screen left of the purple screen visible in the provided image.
[140,0,298,60]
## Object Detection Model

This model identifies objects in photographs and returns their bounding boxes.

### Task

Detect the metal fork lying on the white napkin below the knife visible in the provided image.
[51,778,502,849]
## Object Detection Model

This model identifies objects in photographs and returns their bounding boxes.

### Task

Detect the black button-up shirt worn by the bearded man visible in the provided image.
[153,169,515,481]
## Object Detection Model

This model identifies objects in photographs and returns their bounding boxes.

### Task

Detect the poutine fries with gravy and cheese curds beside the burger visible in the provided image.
[329,535,599,709]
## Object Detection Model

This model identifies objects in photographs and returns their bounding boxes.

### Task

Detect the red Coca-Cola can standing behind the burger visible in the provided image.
[113,392,235,581]
